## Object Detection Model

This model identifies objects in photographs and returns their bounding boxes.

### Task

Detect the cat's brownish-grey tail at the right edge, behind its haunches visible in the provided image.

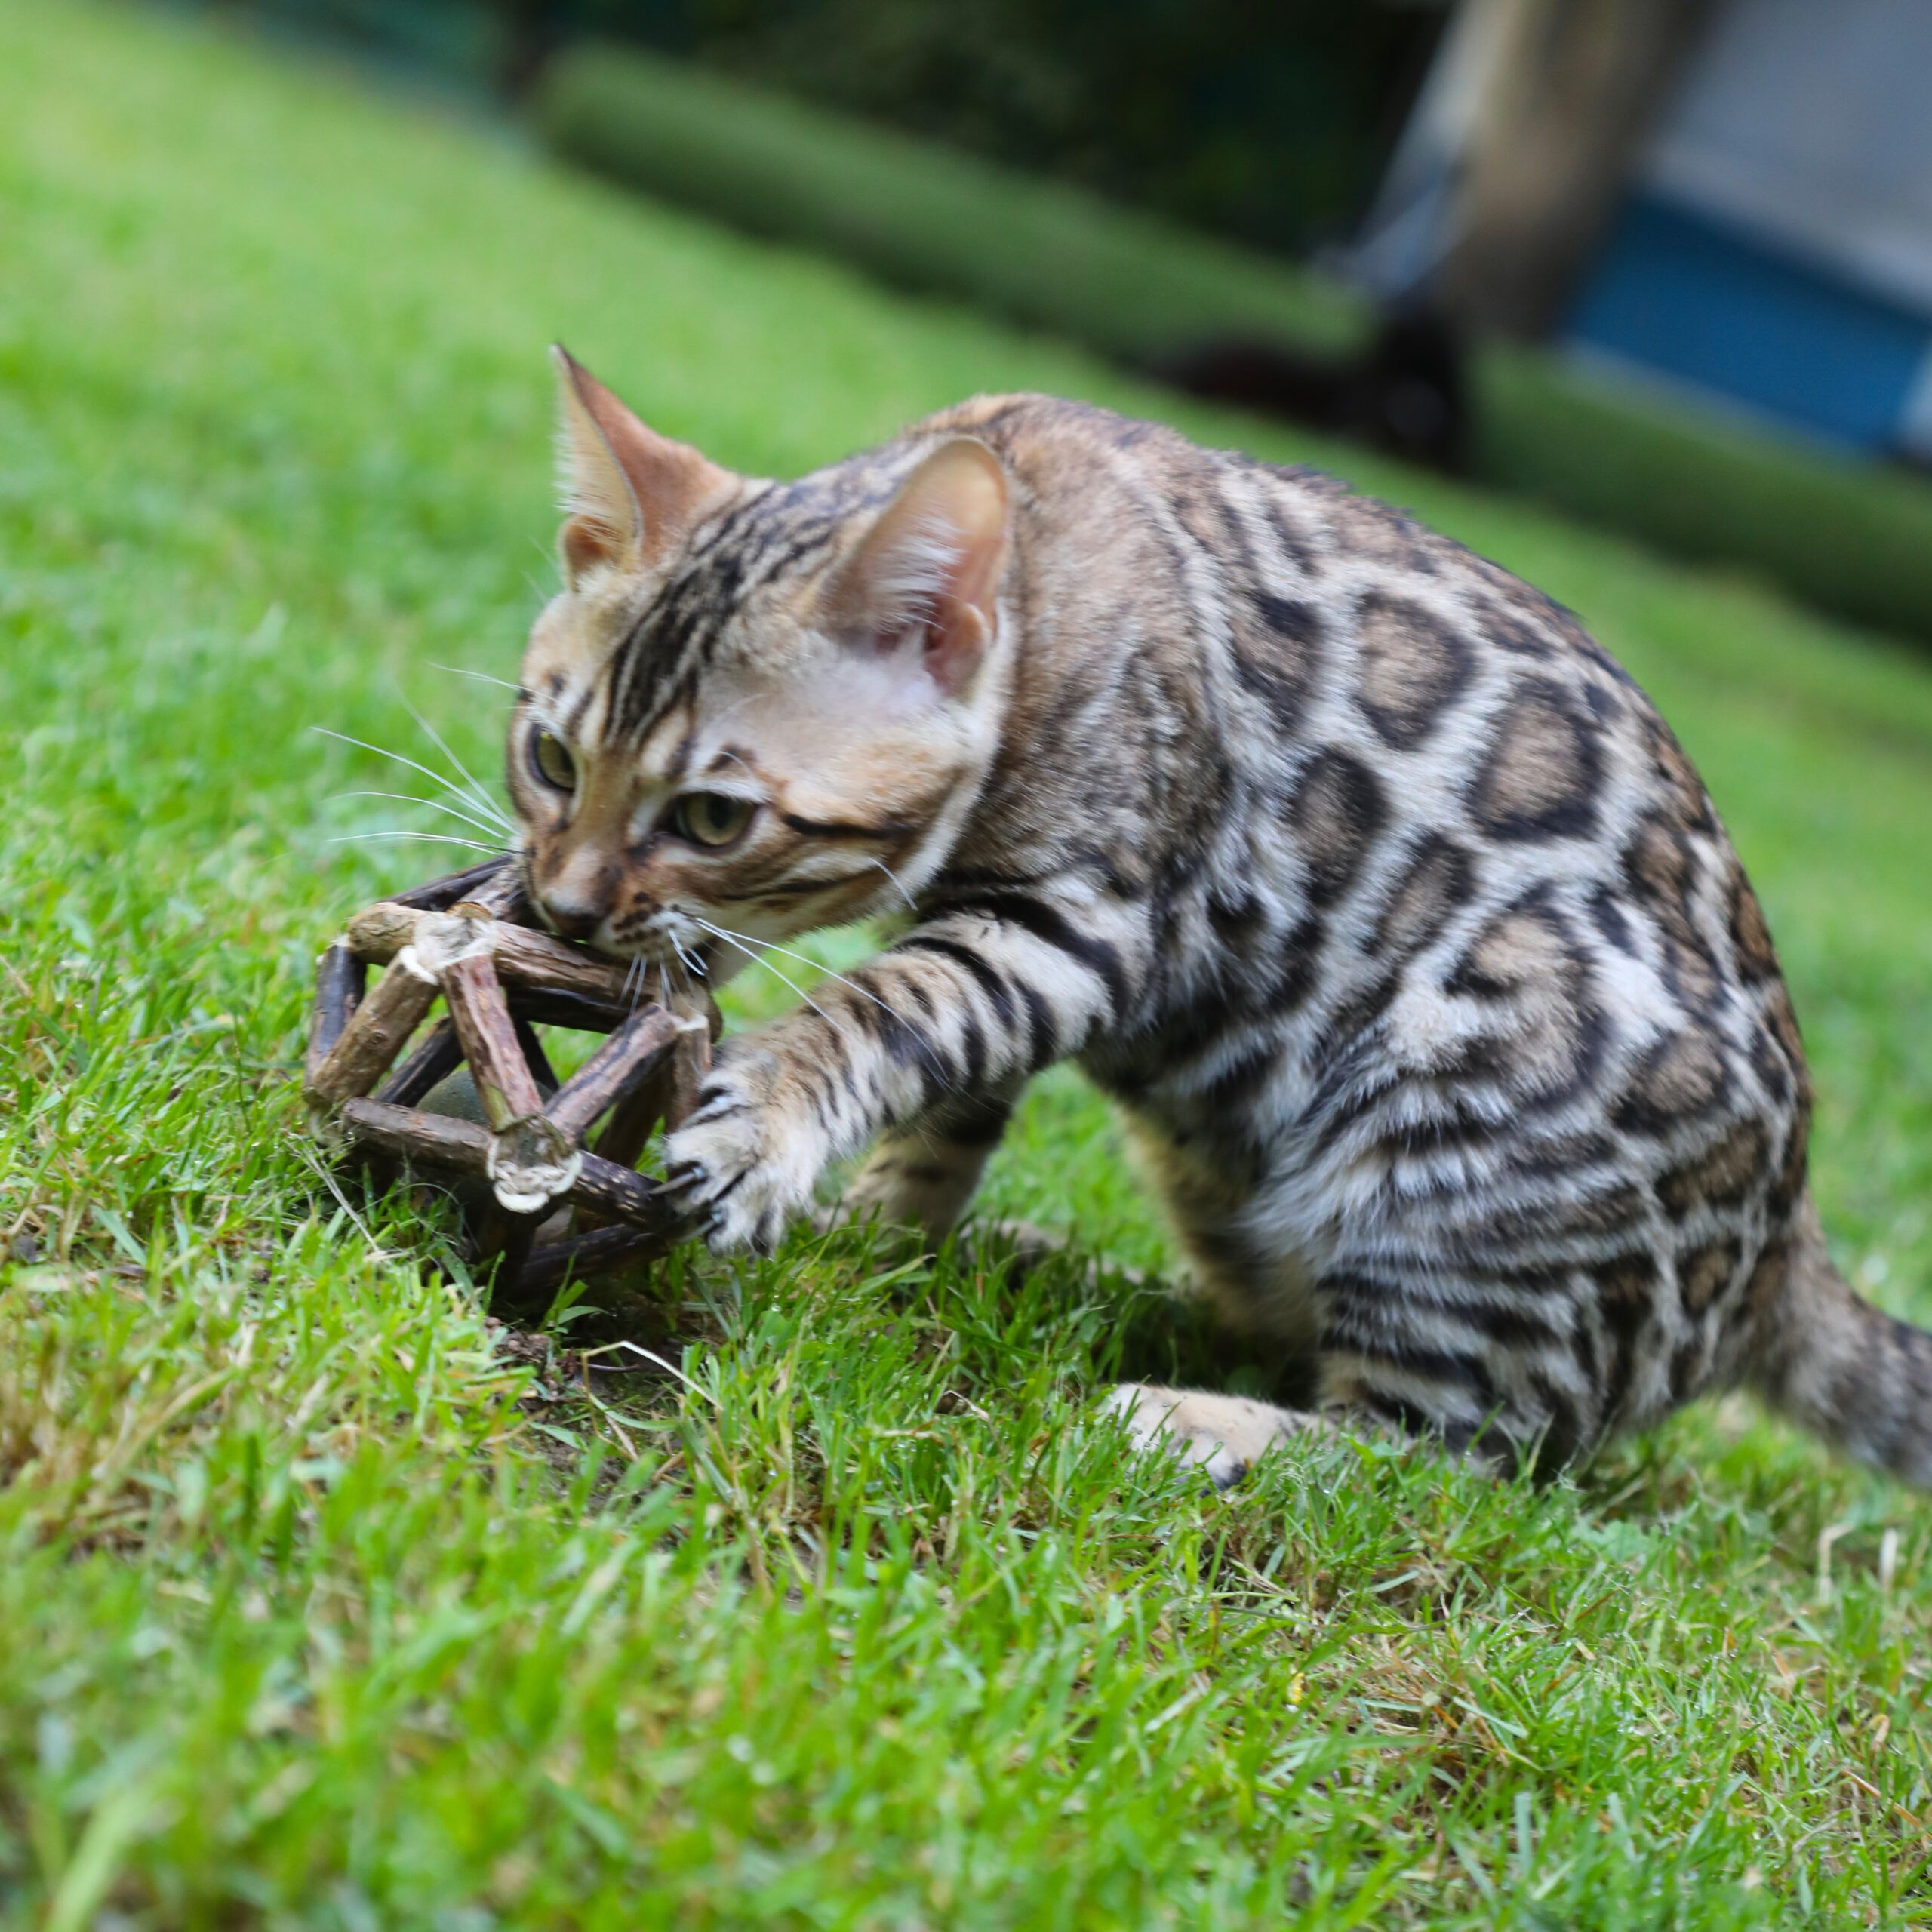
[1752,1201,1932,1490]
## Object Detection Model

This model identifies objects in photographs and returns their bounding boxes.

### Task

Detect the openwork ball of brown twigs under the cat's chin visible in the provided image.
[303,860,721,1294]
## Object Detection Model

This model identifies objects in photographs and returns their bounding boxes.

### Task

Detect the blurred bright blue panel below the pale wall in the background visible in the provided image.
[1571,191,1932,448]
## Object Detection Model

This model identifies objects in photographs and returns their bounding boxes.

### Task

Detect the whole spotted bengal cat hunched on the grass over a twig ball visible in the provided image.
[510,352,1932,1482]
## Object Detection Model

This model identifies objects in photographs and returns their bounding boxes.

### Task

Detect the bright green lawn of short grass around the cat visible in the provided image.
[0,0,1932,1932]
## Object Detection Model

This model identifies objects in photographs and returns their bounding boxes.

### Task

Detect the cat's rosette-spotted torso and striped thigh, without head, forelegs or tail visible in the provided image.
[888,396,1808,1441]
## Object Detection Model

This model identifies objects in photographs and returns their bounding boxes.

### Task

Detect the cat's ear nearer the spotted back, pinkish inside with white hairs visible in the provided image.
[831,437,1007,697]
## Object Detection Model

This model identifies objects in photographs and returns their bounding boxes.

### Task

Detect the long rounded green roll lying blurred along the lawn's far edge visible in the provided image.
[537,42,1932,641]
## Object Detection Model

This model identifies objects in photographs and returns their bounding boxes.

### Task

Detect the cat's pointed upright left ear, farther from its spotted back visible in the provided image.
[551,346,732,583]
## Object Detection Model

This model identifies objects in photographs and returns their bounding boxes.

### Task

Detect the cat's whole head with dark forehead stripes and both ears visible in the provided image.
[508,349,1008,960]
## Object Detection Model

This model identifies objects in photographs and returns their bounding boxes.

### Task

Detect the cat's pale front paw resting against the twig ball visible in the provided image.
[665,1049,825,1254]
